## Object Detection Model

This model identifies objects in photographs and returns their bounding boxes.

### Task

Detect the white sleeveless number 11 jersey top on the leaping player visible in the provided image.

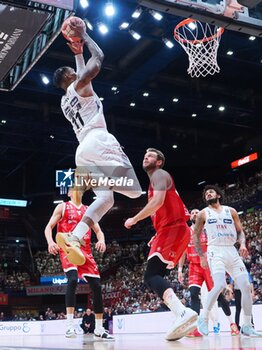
[61,82,107,142]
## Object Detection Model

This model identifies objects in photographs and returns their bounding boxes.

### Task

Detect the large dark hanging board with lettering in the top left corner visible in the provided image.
[0,0,74,91]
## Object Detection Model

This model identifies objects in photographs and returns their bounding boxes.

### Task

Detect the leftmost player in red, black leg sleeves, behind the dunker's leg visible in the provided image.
[45,189,114,340]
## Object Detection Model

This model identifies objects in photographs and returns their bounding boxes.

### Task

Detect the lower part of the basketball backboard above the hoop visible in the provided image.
[138,0,262,37]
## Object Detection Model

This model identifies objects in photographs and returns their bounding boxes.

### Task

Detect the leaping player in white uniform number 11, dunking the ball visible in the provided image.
[54,21,142,265]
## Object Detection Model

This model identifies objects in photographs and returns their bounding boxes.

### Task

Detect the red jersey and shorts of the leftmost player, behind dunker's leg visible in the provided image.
[57,201,100,279]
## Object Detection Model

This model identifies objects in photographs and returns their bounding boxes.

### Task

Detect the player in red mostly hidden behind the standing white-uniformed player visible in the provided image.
[178,209,239,337]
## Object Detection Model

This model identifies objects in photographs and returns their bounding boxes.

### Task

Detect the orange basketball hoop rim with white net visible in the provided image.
[174,18,224,78]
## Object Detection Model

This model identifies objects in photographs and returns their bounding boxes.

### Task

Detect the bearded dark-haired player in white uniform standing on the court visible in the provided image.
[194,185,262,336]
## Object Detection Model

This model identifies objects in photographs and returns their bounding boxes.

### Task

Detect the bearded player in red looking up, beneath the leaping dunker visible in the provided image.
[125,148,197,340]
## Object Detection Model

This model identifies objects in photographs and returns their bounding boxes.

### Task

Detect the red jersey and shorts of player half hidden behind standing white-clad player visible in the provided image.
[186,226,213,291]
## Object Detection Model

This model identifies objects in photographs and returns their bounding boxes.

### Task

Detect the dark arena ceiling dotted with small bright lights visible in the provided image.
[0,0,262,197]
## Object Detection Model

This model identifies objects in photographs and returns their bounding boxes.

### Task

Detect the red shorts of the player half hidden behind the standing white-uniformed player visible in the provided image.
[188,262,213,291]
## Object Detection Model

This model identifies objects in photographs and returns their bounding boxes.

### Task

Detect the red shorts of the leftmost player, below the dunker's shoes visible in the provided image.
[59,248,100,279]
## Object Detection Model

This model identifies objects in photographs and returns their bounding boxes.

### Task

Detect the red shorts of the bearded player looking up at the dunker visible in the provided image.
[148,219,190,269]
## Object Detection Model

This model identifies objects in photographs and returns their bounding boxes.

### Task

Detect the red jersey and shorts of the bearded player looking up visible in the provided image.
[148,180,190,269]
